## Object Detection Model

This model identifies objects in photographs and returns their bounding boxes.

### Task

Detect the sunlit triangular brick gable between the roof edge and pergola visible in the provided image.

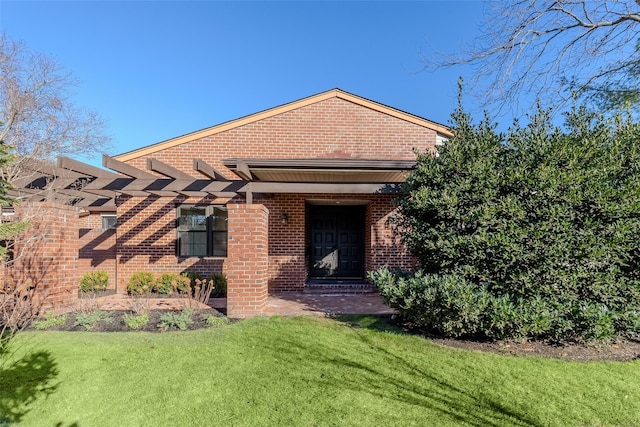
[127,98,436,179]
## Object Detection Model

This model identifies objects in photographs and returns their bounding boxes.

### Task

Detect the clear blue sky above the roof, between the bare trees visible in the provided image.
[0,0,483,164]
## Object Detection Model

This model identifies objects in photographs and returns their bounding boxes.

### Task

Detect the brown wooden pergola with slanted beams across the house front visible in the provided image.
[9,155,415,212]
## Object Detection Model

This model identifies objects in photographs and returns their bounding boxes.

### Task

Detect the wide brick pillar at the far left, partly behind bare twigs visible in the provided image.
[9,202,79,313]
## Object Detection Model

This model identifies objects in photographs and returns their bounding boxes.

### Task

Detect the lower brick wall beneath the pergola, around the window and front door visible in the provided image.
[111,194,412,292]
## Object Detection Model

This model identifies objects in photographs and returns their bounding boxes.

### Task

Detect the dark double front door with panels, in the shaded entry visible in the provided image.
[309,205,365,279]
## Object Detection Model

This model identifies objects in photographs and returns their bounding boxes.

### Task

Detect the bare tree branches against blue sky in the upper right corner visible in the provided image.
[438,0,640,111]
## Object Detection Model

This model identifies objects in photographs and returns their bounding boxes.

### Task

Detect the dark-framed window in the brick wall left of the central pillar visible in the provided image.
[177,205,227,257]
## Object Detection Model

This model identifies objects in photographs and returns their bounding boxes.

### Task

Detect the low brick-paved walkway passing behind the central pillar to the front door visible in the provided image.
[87,292,394,316]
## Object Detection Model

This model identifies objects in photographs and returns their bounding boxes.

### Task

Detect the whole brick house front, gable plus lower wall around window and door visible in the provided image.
[107,98,436,291]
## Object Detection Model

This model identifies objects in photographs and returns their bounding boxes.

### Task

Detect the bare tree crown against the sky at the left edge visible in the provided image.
[0,33,109,186]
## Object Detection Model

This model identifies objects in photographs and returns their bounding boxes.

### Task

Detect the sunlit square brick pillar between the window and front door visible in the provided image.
[225,204,269,318]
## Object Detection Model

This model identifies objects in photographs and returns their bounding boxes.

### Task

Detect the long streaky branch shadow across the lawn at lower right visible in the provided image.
[264,316,541,427]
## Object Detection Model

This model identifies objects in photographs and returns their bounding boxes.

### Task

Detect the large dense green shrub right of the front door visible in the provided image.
[372,98,640,340]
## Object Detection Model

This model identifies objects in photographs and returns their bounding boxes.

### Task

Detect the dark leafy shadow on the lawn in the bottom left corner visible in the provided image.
[0,351,58,426]
